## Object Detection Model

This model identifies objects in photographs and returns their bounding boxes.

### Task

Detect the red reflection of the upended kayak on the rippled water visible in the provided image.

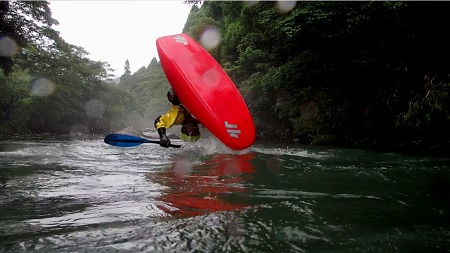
[148,153,255,217]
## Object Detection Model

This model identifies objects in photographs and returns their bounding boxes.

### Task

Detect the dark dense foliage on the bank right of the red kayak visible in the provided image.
[180,1,450,154]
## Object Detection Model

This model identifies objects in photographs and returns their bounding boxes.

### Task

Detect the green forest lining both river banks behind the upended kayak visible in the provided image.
[0,1,450,154]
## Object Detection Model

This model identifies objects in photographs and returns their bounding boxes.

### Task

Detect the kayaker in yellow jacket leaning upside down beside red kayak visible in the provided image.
[154,88,200,148]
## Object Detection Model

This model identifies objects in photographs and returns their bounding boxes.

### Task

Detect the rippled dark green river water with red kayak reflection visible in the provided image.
[0,135,450,253]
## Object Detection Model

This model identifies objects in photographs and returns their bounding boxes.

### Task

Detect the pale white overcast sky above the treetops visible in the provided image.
[50,0,191,76]
